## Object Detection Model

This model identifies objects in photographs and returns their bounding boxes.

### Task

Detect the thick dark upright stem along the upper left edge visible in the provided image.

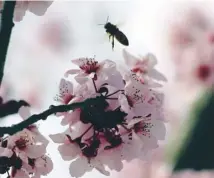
[0,1,16,85]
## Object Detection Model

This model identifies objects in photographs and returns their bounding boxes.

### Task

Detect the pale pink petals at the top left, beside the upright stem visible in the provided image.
[0,0,53,22]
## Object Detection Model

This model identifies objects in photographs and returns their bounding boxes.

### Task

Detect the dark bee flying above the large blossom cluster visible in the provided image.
[99,17,129,50]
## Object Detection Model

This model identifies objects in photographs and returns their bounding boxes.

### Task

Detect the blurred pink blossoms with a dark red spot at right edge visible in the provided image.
[169,8,214,88]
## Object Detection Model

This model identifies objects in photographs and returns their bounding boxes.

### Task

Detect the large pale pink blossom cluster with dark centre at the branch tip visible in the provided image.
[50,50,166,177]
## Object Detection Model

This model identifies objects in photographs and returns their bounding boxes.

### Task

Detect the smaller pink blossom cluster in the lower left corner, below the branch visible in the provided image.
[0,106,53,178]
